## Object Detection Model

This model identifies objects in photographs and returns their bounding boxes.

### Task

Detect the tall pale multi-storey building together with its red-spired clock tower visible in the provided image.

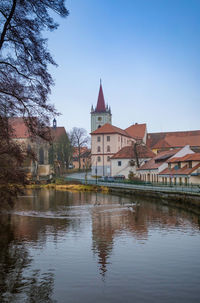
[91,83,147,176]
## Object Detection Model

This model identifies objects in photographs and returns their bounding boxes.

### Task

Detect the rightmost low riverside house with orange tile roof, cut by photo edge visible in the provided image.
[159,153,200,185]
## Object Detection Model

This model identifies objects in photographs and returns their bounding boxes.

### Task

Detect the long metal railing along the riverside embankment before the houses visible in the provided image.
[65,177,200,195]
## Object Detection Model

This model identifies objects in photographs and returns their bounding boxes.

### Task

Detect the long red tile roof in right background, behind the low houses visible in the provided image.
[147,130,200,149]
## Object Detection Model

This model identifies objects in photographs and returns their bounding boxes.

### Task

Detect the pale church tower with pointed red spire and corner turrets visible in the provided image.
[91,80,112,132]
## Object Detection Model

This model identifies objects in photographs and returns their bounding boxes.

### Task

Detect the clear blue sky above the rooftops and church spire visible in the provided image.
[47,0,200,133]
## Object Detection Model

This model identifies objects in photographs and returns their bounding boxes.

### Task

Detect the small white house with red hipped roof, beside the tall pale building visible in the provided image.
[110,143,155,178]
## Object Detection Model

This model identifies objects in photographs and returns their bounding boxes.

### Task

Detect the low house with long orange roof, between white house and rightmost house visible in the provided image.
[137,145,194,182]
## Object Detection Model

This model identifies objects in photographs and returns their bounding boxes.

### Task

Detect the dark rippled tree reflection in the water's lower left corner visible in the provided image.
[0,216,55,303]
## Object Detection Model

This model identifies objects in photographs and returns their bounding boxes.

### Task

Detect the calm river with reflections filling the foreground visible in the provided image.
[0,189,200,303]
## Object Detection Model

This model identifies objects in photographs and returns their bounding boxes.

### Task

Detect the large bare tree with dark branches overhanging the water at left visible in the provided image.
[0,0,68,205]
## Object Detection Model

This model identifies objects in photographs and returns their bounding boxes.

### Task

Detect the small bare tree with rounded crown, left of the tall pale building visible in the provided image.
[70,127,89,170]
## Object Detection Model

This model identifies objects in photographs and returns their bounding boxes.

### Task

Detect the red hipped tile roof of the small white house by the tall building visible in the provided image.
[111,145,155,159]
